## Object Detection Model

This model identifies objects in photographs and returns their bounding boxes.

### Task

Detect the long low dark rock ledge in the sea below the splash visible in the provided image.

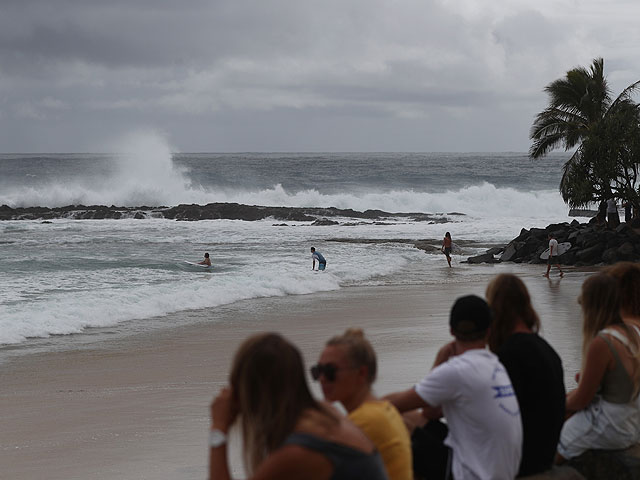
[0,203,460,225]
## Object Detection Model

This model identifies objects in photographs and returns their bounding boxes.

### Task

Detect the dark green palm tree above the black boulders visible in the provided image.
[529,58,640,207]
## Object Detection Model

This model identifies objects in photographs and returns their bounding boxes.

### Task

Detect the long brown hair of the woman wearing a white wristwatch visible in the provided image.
[230,333,338,473]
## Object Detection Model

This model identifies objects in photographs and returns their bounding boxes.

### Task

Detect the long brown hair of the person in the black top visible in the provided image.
[486,273,540,352]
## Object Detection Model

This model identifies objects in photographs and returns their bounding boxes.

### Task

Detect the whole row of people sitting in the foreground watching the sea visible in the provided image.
[209,262,640,480]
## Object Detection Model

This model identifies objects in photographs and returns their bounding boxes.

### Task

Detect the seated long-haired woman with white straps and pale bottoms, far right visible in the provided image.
[558,273,640,461]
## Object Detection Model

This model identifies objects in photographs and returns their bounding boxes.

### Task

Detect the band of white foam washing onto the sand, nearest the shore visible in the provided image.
[0,235,405,344]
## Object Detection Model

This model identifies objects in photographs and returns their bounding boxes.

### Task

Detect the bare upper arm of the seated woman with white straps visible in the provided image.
[566,337,613,413]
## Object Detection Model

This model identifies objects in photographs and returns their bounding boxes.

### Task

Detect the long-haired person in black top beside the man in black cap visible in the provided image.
[486,274,565,476]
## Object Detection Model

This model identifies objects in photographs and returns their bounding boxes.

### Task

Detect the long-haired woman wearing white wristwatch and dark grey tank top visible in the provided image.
[209,333,387,480]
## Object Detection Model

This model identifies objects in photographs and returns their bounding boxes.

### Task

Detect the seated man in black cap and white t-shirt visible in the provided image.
[386,295,522,480]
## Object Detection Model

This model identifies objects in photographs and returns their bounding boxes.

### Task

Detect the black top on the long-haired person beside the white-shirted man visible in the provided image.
[497,333,565,476]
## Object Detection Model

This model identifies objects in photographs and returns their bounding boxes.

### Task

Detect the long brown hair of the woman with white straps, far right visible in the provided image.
[579,273,640,396]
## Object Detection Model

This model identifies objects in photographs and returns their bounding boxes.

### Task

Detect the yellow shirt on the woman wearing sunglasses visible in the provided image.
[349,400,413,480]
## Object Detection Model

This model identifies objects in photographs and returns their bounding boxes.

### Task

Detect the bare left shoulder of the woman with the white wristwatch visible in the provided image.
[251,445,333,480]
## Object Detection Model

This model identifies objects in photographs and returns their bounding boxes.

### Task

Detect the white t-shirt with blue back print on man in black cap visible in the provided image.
[415,349,522,480]
